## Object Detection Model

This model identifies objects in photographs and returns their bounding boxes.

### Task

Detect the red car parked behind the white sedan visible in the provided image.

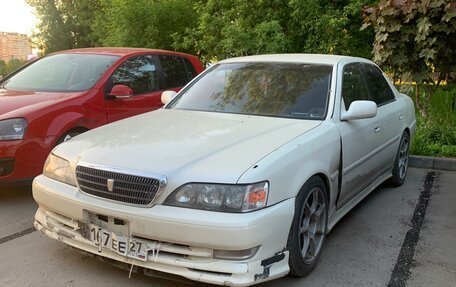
[0,48,203,186]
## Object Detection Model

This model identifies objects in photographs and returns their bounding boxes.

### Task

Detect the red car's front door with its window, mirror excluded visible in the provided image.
[105,55,162,122]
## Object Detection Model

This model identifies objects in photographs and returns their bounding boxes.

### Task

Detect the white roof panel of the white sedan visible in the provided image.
[220,54,371,65]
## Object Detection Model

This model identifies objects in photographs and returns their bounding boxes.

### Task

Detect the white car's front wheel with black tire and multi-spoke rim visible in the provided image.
[287,176,328,277]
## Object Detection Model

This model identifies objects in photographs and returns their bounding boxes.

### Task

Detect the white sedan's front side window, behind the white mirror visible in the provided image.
[342,63,369,110]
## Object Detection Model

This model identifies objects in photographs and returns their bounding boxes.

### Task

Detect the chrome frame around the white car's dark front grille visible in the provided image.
[74,161,168,208]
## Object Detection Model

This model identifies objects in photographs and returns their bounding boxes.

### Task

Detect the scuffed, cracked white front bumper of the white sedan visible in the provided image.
[33,176,294,286]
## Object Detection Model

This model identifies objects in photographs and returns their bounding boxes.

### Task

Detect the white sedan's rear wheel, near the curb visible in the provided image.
[389,131,410,187]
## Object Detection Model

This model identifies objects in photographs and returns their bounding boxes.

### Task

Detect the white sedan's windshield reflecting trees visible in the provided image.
[170,62,332,120]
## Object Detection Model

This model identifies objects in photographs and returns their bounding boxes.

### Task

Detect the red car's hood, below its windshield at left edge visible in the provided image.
[0,89,82,119]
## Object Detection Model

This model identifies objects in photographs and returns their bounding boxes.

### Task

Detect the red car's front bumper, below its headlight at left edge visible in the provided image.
[0,137,55,185]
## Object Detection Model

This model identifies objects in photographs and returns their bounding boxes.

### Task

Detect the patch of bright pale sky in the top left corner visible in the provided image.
[0,0,37,35]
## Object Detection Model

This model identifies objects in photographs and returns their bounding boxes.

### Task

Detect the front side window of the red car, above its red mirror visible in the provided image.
[110,55,159,95]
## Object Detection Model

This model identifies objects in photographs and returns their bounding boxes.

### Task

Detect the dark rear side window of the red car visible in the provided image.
[158,55,191,89]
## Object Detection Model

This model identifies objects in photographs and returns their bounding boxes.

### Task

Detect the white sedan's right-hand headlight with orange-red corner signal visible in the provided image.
[164,181,269,212]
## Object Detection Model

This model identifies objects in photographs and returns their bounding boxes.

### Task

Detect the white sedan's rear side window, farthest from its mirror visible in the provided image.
[363,64,394,106]
